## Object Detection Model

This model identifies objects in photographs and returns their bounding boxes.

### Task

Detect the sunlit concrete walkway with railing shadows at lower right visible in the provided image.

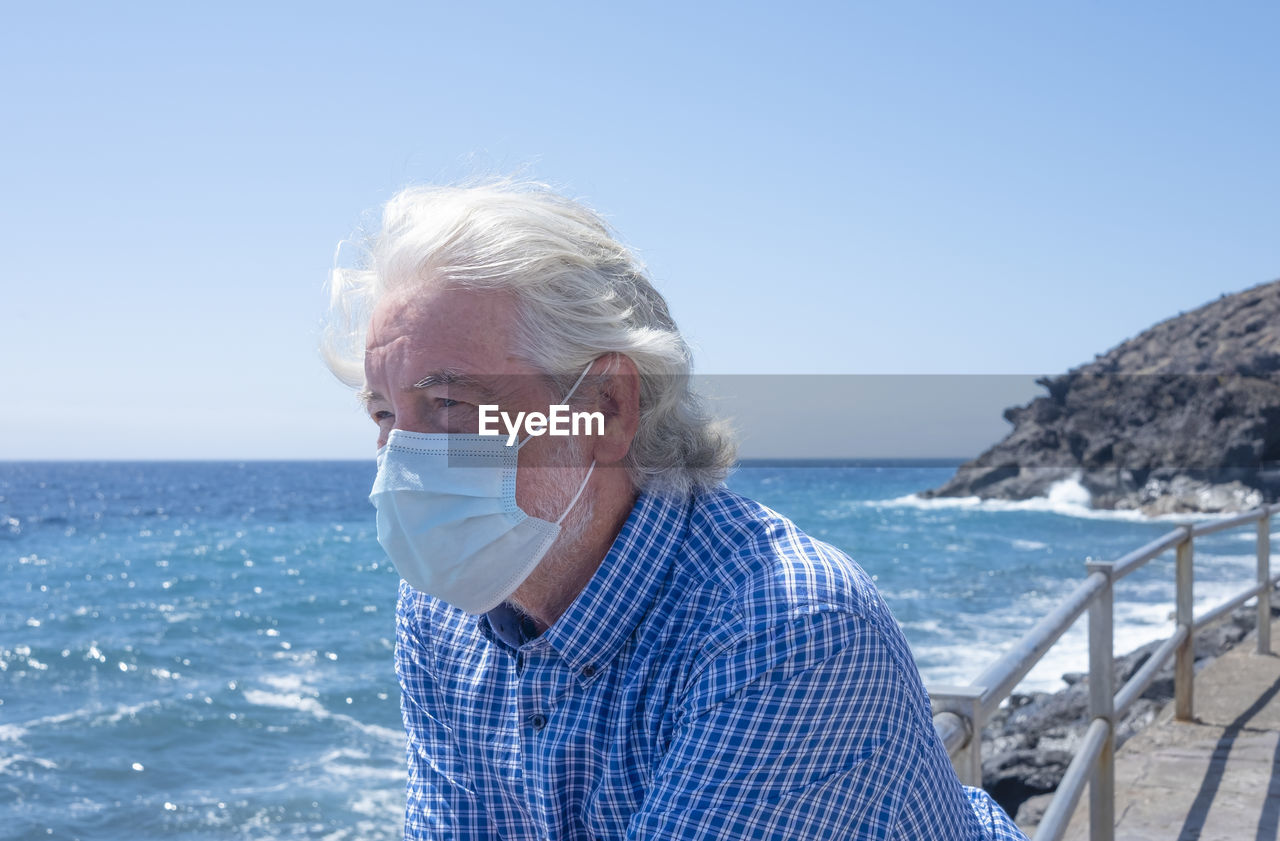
[1066,620,1280,841]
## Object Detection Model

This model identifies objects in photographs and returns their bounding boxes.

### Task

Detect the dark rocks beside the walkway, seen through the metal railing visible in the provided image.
[982,594,1280,826]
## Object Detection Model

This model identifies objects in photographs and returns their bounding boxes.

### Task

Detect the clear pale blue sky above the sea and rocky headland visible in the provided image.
[0,3,1280,458]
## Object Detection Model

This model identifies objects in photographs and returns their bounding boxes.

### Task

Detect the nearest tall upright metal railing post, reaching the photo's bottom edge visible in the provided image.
[1085,561,1116,841]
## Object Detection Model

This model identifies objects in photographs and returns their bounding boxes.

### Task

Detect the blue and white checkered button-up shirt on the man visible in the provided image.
[396,489,1025,841]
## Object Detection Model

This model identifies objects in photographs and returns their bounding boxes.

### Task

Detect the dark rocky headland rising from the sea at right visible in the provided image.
[922,280,1280,513]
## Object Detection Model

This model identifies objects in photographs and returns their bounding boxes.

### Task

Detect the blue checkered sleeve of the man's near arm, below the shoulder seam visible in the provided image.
[627,609,1020,841]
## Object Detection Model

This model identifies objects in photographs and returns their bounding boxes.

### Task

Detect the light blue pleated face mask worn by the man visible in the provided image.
[369,363,595,614]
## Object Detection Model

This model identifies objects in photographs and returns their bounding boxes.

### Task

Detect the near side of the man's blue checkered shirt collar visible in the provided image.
[541,493,691,684]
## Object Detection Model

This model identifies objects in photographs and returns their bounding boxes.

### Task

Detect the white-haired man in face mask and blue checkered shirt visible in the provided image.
[325,183,1024,841]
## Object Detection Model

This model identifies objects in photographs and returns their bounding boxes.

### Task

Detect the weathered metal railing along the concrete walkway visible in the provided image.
[929,503,1280,841]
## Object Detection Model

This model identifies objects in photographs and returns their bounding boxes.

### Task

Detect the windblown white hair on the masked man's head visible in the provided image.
[321,180,735,494]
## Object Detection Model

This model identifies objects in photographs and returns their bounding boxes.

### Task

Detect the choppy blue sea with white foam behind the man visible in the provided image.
[0,461,1269,841]
